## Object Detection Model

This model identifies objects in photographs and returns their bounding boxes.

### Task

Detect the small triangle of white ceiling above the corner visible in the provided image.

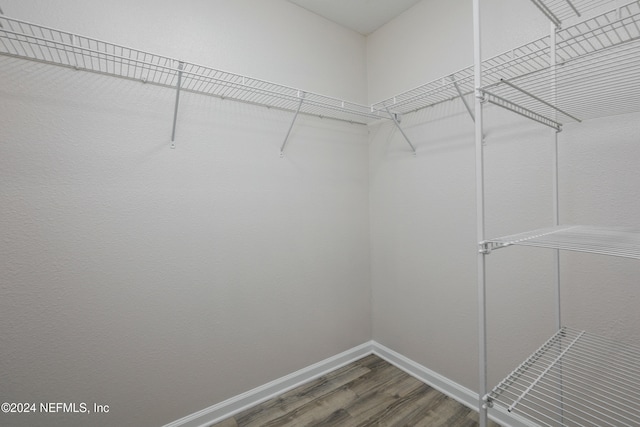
[289,0,421,36]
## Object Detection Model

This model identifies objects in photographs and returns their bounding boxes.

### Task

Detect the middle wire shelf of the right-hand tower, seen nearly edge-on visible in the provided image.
[485,225,640,259]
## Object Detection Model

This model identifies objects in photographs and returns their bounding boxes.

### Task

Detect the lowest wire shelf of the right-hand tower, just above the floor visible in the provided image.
[484,327,640,427]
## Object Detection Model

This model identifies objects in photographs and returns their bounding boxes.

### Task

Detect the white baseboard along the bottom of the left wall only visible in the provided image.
[163,341,373,427]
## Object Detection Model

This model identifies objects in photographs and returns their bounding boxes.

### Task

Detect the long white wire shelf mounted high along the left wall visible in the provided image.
[0,16,386,124]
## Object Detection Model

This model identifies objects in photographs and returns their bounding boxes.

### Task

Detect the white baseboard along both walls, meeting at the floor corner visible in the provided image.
[163,341,530,427]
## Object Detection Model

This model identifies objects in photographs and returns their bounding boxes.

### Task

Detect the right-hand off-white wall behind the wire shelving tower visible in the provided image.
[367,0,640,390]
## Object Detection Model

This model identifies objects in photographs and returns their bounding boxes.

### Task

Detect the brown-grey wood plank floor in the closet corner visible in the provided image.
[211,355,497,427]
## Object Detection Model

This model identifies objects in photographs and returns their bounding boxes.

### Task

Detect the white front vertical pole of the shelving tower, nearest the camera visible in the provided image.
[473,0,488,427]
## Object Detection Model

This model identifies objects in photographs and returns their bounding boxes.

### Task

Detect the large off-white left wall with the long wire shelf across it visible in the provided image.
[0,0,371,426]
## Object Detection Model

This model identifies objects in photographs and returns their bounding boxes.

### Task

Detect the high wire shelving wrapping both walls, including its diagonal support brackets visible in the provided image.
[0,15,560,154]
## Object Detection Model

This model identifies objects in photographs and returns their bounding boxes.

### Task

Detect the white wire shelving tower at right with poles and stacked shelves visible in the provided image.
[474,0,640,426]
